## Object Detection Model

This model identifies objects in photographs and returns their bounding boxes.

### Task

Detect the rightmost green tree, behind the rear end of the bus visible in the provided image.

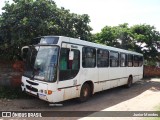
[130,24,160,61]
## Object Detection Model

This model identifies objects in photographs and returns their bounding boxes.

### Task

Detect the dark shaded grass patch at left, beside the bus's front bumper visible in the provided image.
[0,86,30,99]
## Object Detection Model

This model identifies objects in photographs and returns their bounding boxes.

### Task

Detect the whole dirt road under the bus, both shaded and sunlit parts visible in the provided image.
[0,79,160,119]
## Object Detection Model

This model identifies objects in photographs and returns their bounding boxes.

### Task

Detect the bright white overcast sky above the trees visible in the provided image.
[0,0,160,33]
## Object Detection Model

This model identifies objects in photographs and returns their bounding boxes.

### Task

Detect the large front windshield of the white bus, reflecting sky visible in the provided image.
[24,46,58,81]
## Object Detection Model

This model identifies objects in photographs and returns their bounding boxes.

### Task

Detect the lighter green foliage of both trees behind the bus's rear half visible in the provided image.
[95,23,160,61]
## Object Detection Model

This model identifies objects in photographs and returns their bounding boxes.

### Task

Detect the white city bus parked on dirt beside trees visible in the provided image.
[21,36,143,103]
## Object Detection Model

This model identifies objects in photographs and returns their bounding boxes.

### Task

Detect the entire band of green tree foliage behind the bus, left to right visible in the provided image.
[0,0,160,61]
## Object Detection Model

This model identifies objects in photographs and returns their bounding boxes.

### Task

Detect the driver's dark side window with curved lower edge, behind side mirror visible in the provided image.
[59,48,80,81]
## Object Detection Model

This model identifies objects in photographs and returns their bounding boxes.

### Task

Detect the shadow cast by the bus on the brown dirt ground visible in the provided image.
[0,79,160,117]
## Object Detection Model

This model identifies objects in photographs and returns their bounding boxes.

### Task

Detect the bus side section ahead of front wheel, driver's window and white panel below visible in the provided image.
[58,43,80,100]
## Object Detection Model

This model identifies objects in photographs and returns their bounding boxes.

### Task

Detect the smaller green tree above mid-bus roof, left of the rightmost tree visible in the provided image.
[95,23,133,50]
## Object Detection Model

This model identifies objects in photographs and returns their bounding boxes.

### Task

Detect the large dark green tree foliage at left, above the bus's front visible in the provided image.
[0,0,92,59]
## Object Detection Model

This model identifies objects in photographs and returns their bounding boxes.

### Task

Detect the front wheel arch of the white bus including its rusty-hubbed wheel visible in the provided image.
[78,81,94,102]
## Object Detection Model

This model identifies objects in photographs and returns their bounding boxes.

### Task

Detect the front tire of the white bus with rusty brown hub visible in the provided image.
[78,83,91,102]
